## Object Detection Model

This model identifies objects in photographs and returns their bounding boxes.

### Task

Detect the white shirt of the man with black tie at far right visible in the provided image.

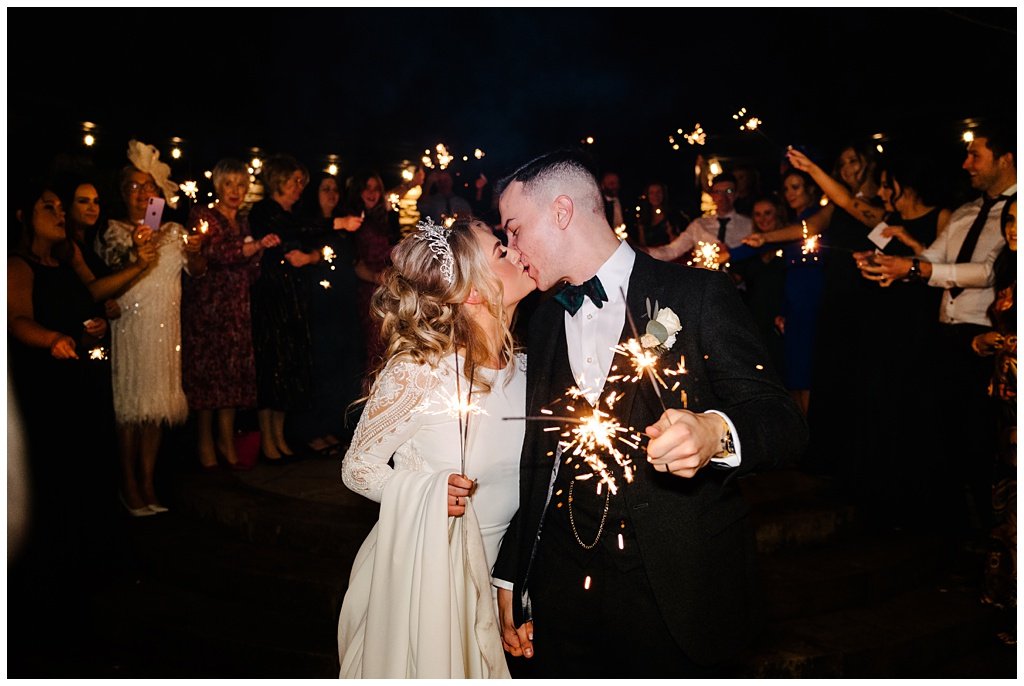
[921,183,1017,327]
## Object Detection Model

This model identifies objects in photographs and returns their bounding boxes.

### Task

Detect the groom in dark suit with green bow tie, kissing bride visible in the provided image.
[494,152,807,677]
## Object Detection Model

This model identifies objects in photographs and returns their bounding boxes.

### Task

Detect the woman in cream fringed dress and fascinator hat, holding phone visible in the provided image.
[96,140,206,517]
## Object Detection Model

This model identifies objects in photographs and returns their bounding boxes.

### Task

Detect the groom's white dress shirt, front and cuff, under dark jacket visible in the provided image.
[564,241,740,467]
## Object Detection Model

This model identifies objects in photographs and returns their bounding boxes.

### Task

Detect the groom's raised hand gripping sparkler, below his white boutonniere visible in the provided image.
[646,410,724,479]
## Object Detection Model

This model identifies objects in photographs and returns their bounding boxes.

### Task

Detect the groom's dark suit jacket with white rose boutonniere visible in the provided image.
[495,252,807,664]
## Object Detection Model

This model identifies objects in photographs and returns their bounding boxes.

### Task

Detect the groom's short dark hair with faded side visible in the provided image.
[498,149,604,213]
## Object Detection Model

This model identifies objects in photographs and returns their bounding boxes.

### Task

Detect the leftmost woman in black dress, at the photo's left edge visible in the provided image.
[7,182,113,556]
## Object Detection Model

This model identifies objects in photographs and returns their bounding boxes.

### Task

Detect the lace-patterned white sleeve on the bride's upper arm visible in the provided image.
[341,360,438,503]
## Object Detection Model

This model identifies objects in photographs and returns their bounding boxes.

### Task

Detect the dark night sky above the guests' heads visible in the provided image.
[7,7,1017,209]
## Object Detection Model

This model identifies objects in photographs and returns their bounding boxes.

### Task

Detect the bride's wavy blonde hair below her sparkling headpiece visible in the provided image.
[370,218,514,392]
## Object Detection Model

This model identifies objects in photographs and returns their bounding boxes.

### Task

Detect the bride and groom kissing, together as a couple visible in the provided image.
[338,151,807,678]
